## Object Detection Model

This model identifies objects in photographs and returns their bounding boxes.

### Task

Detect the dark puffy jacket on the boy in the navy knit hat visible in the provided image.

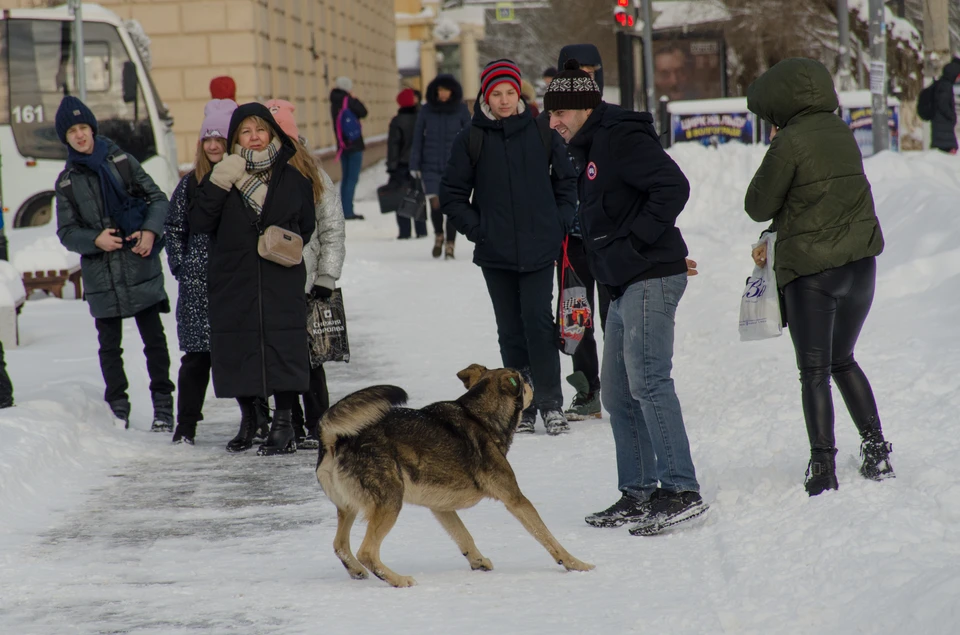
[56,137,170,318]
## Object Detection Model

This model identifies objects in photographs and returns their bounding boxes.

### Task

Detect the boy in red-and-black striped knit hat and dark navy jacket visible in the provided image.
[440,60,577,435]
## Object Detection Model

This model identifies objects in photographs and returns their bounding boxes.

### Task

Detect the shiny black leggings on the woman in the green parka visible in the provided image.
[783,258,880,450]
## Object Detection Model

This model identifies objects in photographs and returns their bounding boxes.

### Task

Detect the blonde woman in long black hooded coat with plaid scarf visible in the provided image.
[188,103,316,455]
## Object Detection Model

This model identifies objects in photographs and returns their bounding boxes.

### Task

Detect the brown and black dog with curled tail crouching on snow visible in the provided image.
[317,364,593,587]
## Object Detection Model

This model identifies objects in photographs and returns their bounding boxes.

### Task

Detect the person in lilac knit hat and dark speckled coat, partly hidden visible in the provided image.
[164,99,266,445]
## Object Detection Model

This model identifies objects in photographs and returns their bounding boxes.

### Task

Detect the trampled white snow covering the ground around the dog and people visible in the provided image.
[0,145,960,635]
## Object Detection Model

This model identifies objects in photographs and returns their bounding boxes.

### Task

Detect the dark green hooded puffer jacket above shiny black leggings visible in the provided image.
[744,58,883,287]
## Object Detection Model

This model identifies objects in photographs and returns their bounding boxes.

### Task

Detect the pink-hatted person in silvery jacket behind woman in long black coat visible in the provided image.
[264,99,346,450]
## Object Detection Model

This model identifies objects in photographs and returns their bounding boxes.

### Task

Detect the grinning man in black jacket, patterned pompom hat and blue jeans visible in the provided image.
[544,60,707,535]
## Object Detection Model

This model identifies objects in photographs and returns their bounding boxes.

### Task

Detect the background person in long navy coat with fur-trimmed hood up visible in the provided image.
[410,75,470,258]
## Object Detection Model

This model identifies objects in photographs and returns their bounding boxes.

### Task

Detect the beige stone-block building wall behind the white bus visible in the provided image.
[0,0,399,167]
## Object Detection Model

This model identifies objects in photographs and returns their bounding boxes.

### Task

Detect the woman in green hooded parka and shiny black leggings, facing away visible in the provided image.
[744,58,894,496]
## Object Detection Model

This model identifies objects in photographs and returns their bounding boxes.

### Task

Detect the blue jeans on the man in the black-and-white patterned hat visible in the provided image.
[600,274,700,500]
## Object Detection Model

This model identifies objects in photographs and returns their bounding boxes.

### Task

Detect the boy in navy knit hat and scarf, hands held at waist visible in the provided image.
[56,96,174,432]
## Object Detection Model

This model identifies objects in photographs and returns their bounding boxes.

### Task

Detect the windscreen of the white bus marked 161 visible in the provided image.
[6,19,157,162]
